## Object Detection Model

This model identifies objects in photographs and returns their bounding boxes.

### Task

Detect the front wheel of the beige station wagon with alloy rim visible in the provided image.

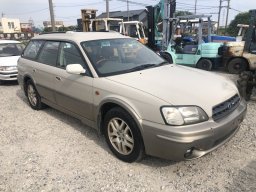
[103,107,144,163]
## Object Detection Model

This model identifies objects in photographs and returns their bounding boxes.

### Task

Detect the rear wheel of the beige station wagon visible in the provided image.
[26,80,44,110]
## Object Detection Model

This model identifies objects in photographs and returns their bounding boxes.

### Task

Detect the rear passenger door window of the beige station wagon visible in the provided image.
[38,41,60,66]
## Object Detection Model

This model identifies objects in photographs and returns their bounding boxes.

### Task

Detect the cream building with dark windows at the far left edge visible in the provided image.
[0,17,21,33]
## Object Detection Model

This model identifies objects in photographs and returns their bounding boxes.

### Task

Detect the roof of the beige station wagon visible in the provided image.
[33,31,129,42]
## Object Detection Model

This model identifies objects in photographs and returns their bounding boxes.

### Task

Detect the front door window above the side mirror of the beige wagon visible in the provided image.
[57,42,85,69]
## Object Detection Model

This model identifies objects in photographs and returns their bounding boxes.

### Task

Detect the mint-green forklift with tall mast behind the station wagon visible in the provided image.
[148,0,225,70]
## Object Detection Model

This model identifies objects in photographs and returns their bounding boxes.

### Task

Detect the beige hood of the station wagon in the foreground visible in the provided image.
[107,65,238,115]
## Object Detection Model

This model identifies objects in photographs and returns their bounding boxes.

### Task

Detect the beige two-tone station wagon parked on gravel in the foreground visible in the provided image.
[18,32,247,162]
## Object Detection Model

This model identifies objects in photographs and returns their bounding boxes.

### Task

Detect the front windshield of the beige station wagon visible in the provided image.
[81,38,168,76]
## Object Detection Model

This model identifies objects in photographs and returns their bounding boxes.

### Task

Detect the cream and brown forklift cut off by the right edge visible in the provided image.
[221,10,256,74]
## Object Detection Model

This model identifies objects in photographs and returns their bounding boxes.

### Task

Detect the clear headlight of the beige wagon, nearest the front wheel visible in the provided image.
[161,106,208,125]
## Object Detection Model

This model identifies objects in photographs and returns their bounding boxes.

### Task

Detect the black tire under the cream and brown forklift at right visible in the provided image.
[227,58,247,74]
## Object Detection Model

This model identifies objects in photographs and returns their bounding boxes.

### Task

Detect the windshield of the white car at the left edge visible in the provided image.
[0,43,24,57]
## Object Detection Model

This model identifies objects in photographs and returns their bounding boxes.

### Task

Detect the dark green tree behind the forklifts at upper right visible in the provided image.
[227,12,250,36]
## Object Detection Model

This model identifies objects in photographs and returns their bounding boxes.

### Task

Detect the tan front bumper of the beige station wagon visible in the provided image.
[142,100,247,161]
